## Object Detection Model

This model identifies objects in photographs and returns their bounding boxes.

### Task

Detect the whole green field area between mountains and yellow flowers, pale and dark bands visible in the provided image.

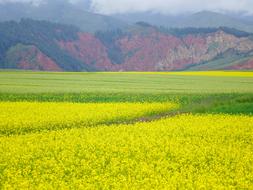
[0,71,253,113]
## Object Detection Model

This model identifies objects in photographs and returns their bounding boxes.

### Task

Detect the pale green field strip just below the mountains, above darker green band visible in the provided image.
[0,72,253,93]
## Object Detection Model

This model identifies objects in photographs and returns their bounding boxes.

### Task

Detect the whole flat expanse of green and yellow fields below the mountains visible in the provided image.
[0,71,253,189]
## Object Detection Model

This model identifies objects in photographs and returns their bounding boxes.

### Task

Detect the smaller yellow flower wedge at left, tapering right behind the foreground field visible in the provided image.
[0,102,178,136]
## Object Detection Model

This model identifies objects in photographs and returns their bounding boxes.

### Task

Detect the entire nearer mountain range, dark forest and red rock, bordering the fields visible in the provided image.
[0,19,253,71]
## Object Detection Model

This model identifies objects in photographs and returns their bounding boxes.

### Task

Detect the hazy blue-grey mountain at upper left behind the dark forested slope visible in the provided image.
[0,0,127,33]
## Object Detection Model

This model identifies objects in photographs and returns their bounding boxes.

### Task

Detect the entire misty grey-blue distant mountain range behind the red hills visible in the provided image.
[0,0,253,33]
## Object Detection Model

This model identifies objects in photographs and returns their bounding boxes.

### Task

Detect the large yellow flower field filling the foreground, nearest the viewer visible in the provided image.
[0,113,253,189]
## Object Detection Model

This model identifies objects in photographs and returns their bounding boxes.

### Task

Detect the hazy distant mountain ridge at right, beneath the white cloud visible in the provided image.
[114,11,253,32]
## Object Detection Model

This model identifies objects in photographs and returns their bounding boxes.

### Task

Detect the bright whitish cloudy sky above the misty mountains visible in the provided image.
[0,0,253,14]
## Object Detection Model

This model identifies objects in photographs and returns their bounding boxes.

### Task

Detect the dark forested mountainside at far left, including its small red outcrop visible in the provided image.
[0,19,95,71]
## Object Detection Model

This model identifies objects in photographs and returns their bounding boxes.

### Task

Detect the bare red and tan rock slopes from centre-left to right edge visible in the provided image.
[58,28,253,71]
